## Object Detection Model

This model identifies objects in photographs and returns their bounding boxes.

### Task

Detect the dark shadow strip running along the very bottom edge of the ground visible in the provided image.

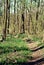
[0,58,44,65]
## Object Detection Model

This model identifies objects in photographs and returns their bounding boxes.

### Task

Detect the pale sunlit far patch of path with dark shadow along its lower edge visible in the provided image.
[27,42,44,51]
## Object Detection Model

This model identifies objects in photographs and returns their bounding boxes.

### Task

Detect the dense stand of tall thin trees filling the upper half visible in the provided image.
[0,0,44,39]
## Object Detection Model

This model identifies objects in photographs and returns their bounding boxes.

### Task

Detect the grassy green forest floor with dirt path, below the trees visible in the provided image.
[0,35,44,65]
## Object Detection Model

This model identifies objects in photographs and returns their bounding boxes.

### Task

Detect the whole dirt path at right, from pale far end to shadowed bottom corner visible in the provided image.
[27,39,44,65]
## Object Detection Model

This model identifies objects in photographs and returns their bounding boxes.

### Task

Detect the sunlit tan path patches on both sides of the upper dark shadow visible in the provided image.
[27,42,44,58]
